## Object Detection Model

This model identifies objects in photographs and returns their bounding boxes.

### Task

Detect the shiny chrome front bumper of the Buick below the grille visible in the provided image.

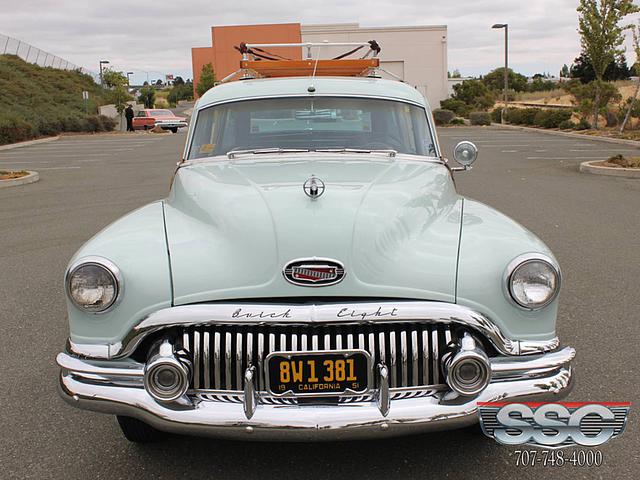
[57,347,575,441]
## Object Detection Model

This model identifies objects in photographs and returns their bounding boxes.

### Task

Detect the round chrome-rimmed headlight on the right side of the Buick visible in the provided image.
[507,255,560,310]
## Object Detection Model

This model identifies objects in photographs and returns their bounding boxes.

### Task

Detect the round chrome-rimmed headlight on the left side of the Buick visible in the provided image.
[66,258,122,313]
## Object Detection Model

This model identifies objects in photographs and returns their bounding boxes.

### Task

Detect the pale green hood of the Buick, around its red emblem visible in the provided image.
[164,154,462,304]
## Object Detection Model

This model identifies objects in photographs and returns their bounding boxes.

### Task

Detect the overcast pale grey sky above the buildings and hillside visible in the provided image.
[0,0,635,84]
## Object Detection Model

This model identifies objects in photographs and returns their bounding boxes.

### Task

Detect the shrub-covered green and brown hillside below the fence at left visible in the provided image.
[0,55,113,144]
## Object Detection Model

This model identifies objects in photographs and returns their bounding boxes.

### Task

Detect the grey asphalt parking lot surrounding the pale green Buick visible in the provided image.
[0,128,640,480]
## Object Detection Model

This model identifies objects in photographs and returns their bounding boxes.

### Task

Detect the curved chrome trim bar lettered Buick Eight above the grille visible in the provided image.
[84,302,558,358]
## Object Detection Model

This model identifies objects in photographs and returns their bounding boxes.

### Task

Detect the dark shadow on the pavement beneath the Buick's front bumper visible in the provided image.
[121,426,500,479]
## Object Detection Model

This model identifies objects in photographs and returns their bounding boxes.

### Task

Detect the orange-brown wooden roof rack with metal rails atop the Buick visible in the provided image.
[221,40,380,83]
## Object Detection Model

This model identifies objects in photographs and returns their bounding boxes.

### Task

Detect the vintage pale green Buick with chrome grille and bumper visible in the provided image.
[57,72,575,442]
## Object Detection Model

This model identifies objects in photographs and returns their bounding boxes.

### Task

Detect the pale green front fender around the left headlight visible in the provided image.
[67,202,172,345]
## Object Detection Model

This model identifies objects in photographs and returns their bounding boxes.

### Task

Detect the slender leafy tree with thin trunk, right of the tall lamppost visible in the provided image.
[578,0,640,130]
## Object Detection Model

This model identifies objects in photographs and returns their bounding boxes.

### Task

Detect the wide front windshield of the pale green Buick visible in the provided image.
[189,97,436,159]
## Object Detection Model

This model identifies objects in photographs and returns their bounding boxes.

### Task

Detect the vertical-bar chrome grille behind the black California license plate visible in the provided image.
[182,322,455,391]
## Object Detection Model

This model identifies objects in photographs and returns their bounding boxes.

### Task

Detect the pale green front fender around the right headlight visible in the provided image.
[456,198,558,341]
